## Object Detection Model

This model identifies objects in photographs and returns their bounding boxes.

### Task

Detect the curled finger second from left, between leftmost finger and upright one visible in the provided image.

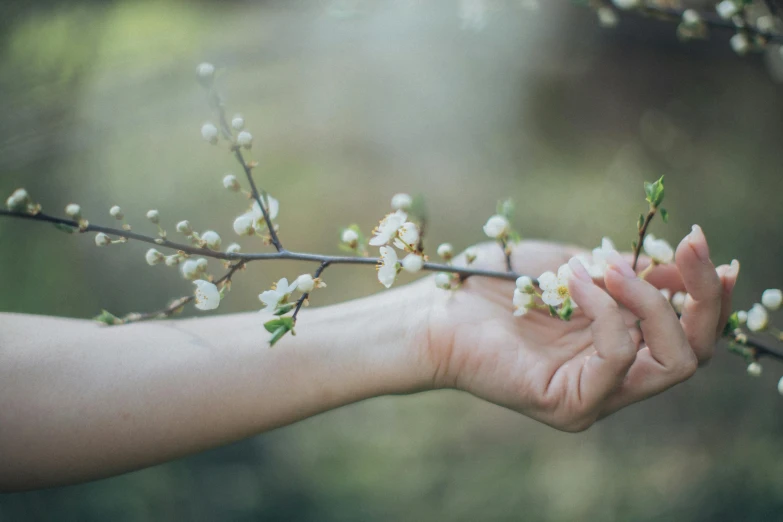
[605,252,696,376]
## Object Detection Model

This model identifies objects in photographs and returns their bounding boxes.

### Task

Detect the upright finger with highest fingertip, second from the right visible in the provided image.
[675,225,724,364]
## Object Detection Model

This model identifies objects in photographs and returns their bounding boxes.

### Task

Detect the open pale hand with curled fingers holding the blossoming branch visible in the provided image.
[428,227,739,431]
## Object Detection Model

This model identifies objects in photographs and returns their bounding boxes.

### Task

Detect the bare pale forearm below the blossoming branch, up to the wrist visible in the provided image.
[0,285,431,490]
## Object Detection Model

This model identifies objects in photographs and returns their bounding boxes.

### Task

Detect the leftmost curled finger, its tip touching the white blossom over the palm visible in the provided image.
[568,258,637,411]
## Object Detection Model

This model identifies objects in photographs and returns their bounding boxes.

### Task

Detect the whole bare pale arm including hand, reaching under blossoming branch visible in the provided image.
[0,229,738,491]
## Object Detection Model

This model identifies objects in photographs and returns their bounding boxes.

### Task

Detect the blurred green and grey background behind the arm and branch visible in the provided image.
[0,0,783,522]
